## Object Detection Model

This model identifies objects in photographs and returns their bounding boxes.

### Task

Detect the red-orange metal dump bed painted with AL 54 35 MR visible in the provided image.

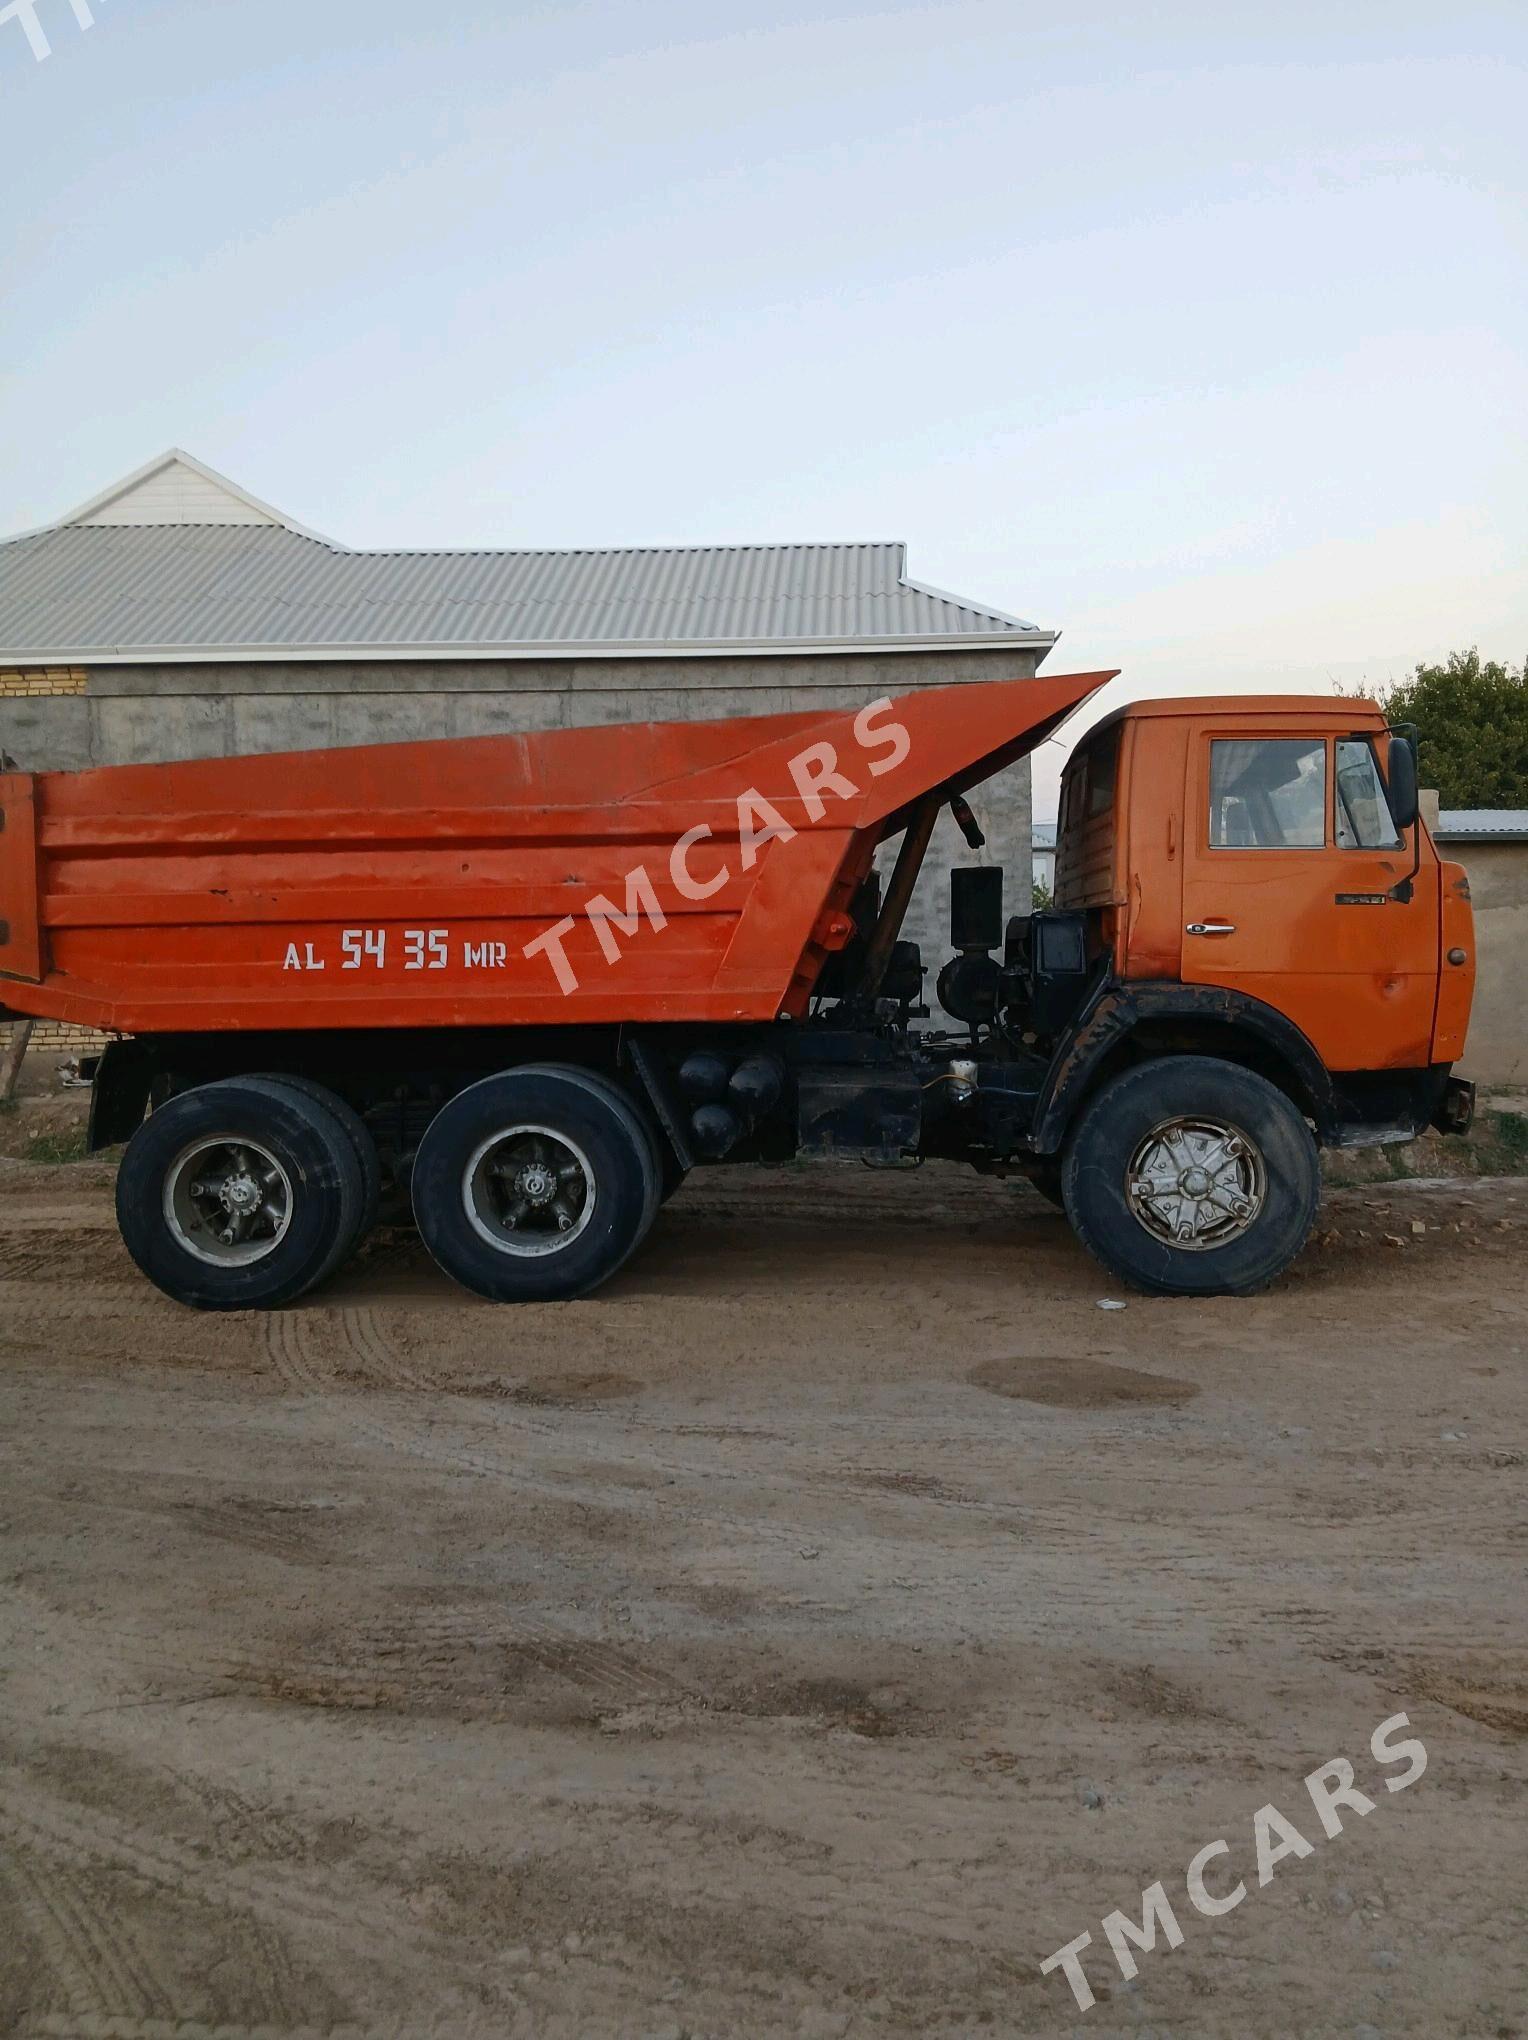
[0,673,1112,1034]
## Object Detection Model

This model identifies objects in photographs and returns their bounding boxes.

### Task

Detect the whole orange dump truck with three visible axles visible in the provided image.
[0,673,1473,1310]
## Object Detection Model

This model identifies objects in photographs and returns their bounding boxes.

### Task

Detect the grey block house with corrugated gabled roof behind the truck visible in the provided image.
[0,451,1055,1052]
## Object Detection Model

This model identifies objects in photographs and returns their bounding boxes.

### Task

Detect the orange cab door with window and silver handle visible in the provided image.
[1181,718,1438,1069]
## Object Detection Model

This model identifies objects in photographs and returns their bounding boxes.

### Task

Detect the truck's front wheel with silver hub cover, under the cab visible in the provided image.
[1061,1055,1322,1295]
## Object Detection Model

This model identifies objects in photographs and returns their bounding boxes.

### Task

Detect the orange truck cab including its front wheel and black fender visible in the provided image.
[901,696,1475,1293]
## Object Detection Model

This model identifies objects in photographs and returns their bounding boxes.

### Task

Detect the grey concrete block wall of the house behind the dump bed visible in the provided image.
[0,649,1034,1020]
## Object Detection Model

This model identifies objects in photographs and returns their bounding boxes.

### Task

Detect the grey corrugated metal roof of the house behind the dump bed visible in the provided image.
[0,524,1053,661]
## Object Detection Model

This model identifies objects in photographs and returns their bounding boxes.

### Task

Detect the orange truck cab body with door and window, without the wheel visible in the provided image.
[1057,696,1473,1073]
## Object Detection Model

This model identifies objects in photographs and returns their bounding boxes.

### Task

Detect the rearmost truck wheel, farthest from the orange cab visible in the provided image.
[116,1077,365,1310]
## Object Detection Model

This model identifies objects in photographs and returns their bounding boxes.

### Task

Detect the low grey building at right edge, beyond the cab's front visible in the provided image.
[1430,808,1528,1085]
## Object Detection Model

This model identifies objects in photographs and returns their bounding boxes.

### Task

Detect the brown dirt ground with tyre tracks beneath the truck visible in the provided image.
[0,1161,1528,2040]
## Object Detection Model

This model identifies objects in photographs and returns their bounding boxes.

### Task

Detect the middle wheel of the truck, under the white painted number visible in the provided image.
[414,1063,659,1304]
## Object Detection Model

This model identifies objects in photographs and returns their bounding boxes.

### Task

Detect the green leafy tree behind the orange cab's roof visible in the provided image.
[1385,647,1528,808]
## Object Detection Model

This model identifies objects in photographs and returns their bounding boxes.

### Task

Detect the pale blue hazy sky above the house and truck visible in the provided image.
[0,0,1528,816]
